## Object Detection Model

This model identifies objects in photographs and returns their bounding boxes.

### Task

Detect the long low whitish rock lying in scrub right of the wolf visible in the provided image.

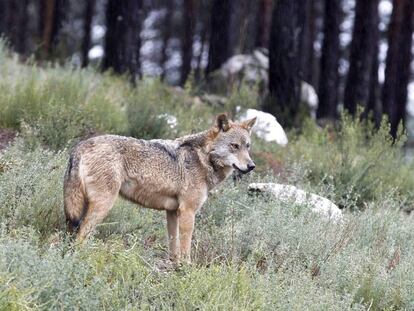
[249,183,343,222]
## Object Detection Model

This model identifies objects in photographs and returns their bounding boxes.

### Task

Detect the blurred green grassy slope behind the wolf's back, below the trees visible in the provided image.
[0,42,210,150]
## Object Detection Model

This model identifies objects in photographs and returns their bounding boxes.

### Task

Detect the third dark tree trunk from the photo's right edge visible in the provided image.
[317,0,342,119]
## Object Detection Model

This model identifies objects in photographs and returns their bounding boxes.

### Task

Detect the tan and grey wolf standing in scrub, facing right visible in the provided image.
[63,114,256,262]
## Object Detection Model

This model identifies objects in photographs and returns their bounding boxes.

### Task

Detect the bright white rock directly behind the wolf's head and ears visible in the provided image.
[239,109,288,147]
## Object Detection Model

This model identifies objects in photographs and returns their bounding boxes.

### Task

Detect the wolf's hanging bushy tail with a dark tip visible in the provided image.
[63,155,86,232]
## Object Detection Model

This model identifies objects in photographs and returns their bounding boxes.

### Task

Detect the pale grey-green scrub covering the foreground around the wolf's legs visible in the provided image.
[0,144,414,310]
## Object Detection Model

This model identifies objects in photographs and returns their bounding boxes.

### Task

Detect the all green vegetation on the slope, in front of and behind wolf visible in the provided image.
[0,42,414,310]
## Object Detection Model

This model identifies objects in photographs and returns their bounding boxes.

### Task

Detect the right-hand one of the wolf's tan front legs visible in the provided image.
[178,206,195,263]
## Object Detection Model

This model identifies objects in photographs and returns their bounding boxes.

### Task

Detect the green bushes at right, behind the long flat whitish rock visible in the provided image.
[277,115,414,209]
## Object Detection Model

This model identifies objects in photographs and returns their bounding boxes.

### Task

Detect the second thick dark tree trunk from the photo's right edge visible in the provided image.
[344,0,379,115]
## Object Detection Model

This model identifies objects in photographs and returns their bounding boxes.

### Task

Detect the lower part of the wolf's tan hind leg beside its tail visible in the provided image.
[76,194,117,242]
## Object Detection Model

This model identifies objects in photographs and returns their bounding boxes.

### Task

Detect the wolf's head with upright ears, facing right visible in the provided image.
[210,114,256,174]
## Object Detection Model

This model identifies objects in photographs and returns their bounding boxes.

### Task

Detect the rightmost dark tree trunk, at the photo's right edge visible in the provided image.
[382,0,414,138]
